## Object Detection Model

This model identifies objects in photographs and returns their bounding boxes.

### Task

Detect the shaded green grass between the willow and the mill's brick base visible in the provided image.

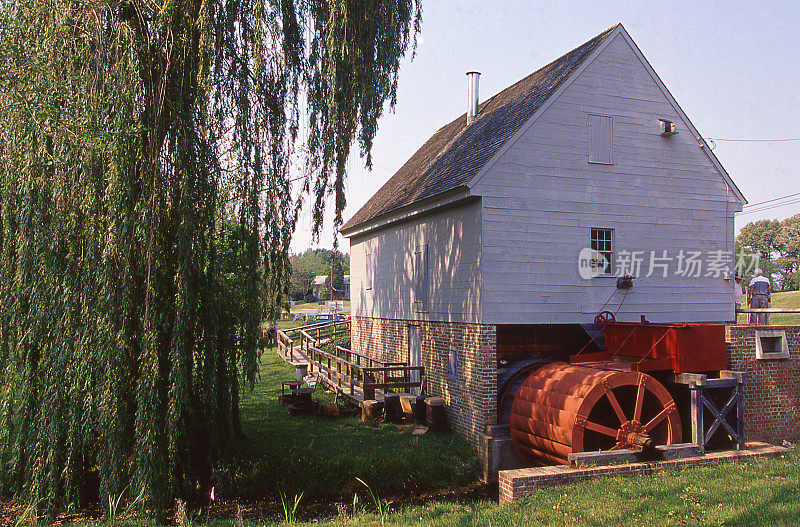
[209,342,477,501]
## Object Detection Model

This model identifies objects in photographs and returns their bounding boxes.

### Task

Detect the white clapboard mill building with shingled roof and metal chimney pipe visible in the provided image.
[342,25,745,456]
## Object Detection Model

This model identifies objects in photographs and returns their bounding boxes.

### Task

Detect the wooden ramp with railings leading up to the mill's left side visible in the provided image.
[278,321,425,405]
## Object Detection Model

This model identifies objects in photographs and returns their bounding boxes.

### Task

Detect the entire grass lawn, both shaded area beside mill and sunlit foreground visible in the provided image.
[7,342,800,527]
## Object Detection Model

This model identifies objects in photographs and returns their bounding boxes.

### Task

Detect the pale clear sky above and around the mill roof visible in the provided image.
[292,0,800,251]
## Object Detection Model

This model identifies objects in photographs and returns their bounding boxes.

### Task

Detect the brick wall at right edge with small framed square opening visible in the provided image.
[726,326,800,443]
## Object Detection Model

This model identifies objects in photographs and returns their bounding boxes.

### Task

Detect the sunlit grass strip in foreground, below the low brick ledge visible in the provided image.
[247,452,800,527]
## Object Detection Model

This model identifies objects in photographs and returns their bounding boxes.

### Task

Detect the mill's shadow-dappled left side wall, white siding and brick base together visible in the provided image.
[351,200,496,446]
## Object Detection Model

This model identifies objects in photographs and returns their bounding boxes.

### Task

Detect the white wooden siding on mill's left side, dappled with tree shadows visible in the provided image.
[350,200,481,322]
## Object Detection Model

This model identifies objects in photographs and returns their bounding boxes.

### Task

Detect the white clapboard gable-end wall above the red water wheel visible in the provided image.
[472,35,740,324]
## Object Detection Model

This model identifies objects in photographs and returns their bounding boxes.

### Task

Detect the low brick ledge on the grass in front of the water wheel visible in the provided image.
[498,443,790,504]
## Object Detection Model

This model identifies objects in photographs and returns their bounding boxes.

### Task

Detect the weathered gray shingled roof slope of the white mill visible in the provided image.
[342,26,616,231]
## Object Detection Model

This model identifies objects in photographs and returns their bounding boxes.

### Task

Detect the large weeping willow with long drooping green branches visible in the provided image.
[0,0,420,510]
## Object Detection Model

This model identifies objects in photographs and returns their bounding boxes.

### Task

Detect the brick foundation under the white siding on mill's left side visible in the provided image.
[351,317,497,447]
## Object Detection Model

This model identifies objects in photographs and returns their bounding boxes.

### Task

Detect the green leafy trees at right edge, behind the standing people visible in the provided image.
[736,214,800,291]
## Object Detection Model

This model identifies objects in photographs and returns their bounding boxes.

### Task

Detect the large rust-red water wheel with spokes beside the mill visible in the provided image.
[510,363,681,464]
